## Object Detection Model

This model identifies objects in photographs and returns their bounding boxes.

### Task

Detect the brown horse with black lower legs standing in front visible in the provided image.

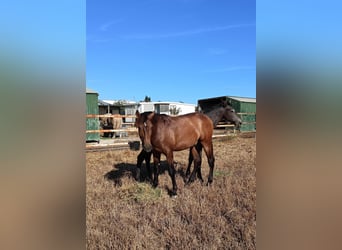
[135,111,215,195]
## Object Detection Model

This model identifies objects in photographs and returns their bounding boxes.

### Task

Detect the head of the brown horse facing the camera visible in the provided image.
[134,110,155,152]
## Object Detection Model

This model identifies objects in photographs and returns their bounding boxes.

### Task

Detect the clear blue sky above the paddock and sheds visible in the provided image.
[86,0,256,104]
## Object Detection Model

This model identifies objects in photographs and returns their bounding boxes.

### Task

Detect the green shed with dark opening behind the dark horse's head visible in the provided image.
[198,96,256,131]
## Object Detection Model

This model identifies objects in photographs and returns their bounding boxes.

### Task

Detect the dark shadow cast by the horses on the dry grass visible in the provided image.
[104,161,190,186]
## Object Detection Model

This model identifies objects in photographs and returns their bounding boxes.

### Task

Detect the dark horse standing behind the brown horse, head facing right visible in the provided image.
[136,101,241,185]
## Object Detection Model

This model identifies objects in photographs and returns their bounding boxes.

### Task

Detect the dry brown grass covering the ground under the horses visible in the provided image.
[86,137,256,249]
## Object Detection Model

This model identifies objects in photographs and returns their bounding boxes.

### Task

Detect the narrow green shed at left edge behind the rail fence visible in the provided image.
[86,88,100,142]
